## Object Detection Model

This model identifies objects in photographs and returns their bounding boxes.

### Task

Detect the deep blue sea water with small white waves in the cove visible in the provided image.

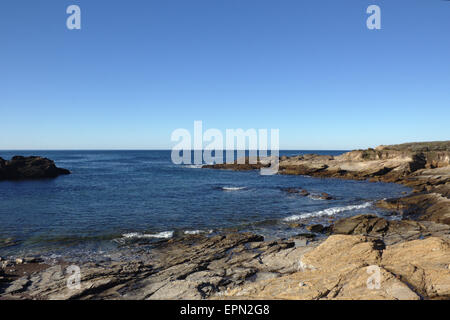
[0,151,409,256]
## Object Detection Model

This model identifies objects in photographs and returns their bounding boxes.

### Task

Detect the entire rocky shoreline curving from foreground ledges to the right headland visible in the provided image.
[0,142,450,300]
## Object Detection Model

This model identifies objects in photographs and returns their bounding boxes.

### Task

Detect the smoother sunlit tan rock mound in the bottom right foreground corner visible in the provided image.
[224,235,450,300]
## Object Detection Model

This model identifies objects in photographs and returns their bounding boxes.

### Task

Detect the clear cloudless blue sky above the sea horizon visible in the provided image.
[0,0,450,149]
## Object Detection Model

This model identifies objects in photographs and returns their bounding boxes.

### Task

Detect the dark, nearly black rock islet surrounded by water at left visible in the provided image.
[0,156,70,180]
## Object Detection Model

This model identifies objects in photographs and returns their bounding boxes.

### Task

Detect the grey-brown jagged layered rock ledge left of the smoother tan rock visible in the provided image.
[0,233,324,299]
